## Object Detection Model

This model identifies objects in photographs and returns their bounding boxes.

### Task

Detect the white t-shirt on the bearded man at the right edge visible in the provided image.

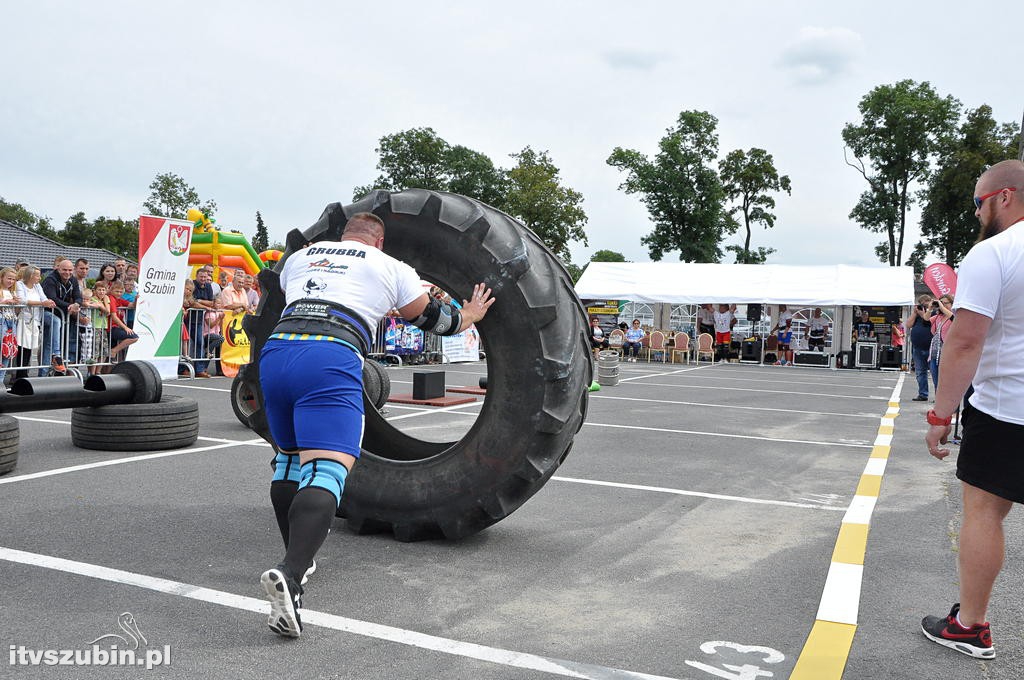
[953,222,1024,425]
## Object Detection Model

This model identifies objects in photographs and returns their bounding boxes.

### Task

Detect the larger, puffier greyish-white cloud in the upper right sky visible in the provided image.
[779,26,864,85]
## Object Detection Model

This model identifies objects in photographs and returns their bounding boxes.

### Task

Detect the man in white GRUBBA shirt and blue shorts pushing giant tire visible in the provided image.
[259,213,495,638]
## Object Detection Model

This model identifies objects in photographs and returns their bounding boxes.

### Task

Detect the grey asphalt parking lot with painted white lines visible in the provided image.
[0,363,1024,680]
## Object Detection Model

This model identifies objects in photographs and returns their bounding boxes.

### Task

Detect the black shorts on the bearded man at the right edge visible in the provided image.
[956,408,1024,503]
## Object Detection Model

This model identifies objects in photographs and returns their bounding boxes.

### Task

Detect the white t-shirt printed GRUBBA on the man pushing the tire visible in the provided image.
[281,241,425,333]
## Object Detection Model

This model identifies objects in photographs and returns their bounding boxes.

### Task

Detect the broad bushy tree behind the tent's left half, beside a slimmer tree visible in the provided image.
[607,111,737,262]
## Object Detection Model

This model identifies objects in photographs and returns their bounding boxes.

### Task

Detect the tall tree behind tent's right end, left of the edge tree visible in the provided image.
[843,80,961,266]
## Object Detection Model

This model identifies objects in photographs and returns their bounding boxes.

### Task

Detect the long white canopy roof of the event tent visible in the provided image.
[575,262,913,306]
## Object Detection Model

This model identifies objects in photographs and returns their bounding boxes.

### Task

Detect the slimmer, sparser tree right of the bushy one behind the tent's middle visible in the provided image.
[718,148,792,264]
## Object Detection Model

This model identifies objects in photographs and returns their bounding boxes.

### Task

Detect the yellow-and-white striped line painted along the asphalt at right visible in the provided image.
[790,374,906,680]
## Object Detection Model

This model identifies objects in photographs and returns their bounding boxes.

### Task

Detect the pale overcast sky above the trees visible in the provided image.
[0,0,1024,264]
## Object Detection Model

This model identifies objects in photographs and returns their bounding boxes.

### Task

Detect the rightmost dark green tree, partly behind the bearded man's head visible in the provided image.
[908,104,1020,268]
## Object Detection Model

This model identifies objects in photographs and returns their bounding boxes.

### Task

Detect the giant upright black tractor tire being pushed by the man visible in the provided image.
[240,189,593,541]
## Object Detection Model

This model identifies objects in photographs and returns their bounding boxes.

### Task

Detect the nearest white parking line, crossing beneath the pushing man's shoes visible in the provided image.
[0,547,674,680]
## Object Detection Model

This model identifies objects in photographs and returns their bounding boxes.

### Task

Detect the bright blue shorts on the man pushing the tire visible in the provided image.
[259,339,362,458]
